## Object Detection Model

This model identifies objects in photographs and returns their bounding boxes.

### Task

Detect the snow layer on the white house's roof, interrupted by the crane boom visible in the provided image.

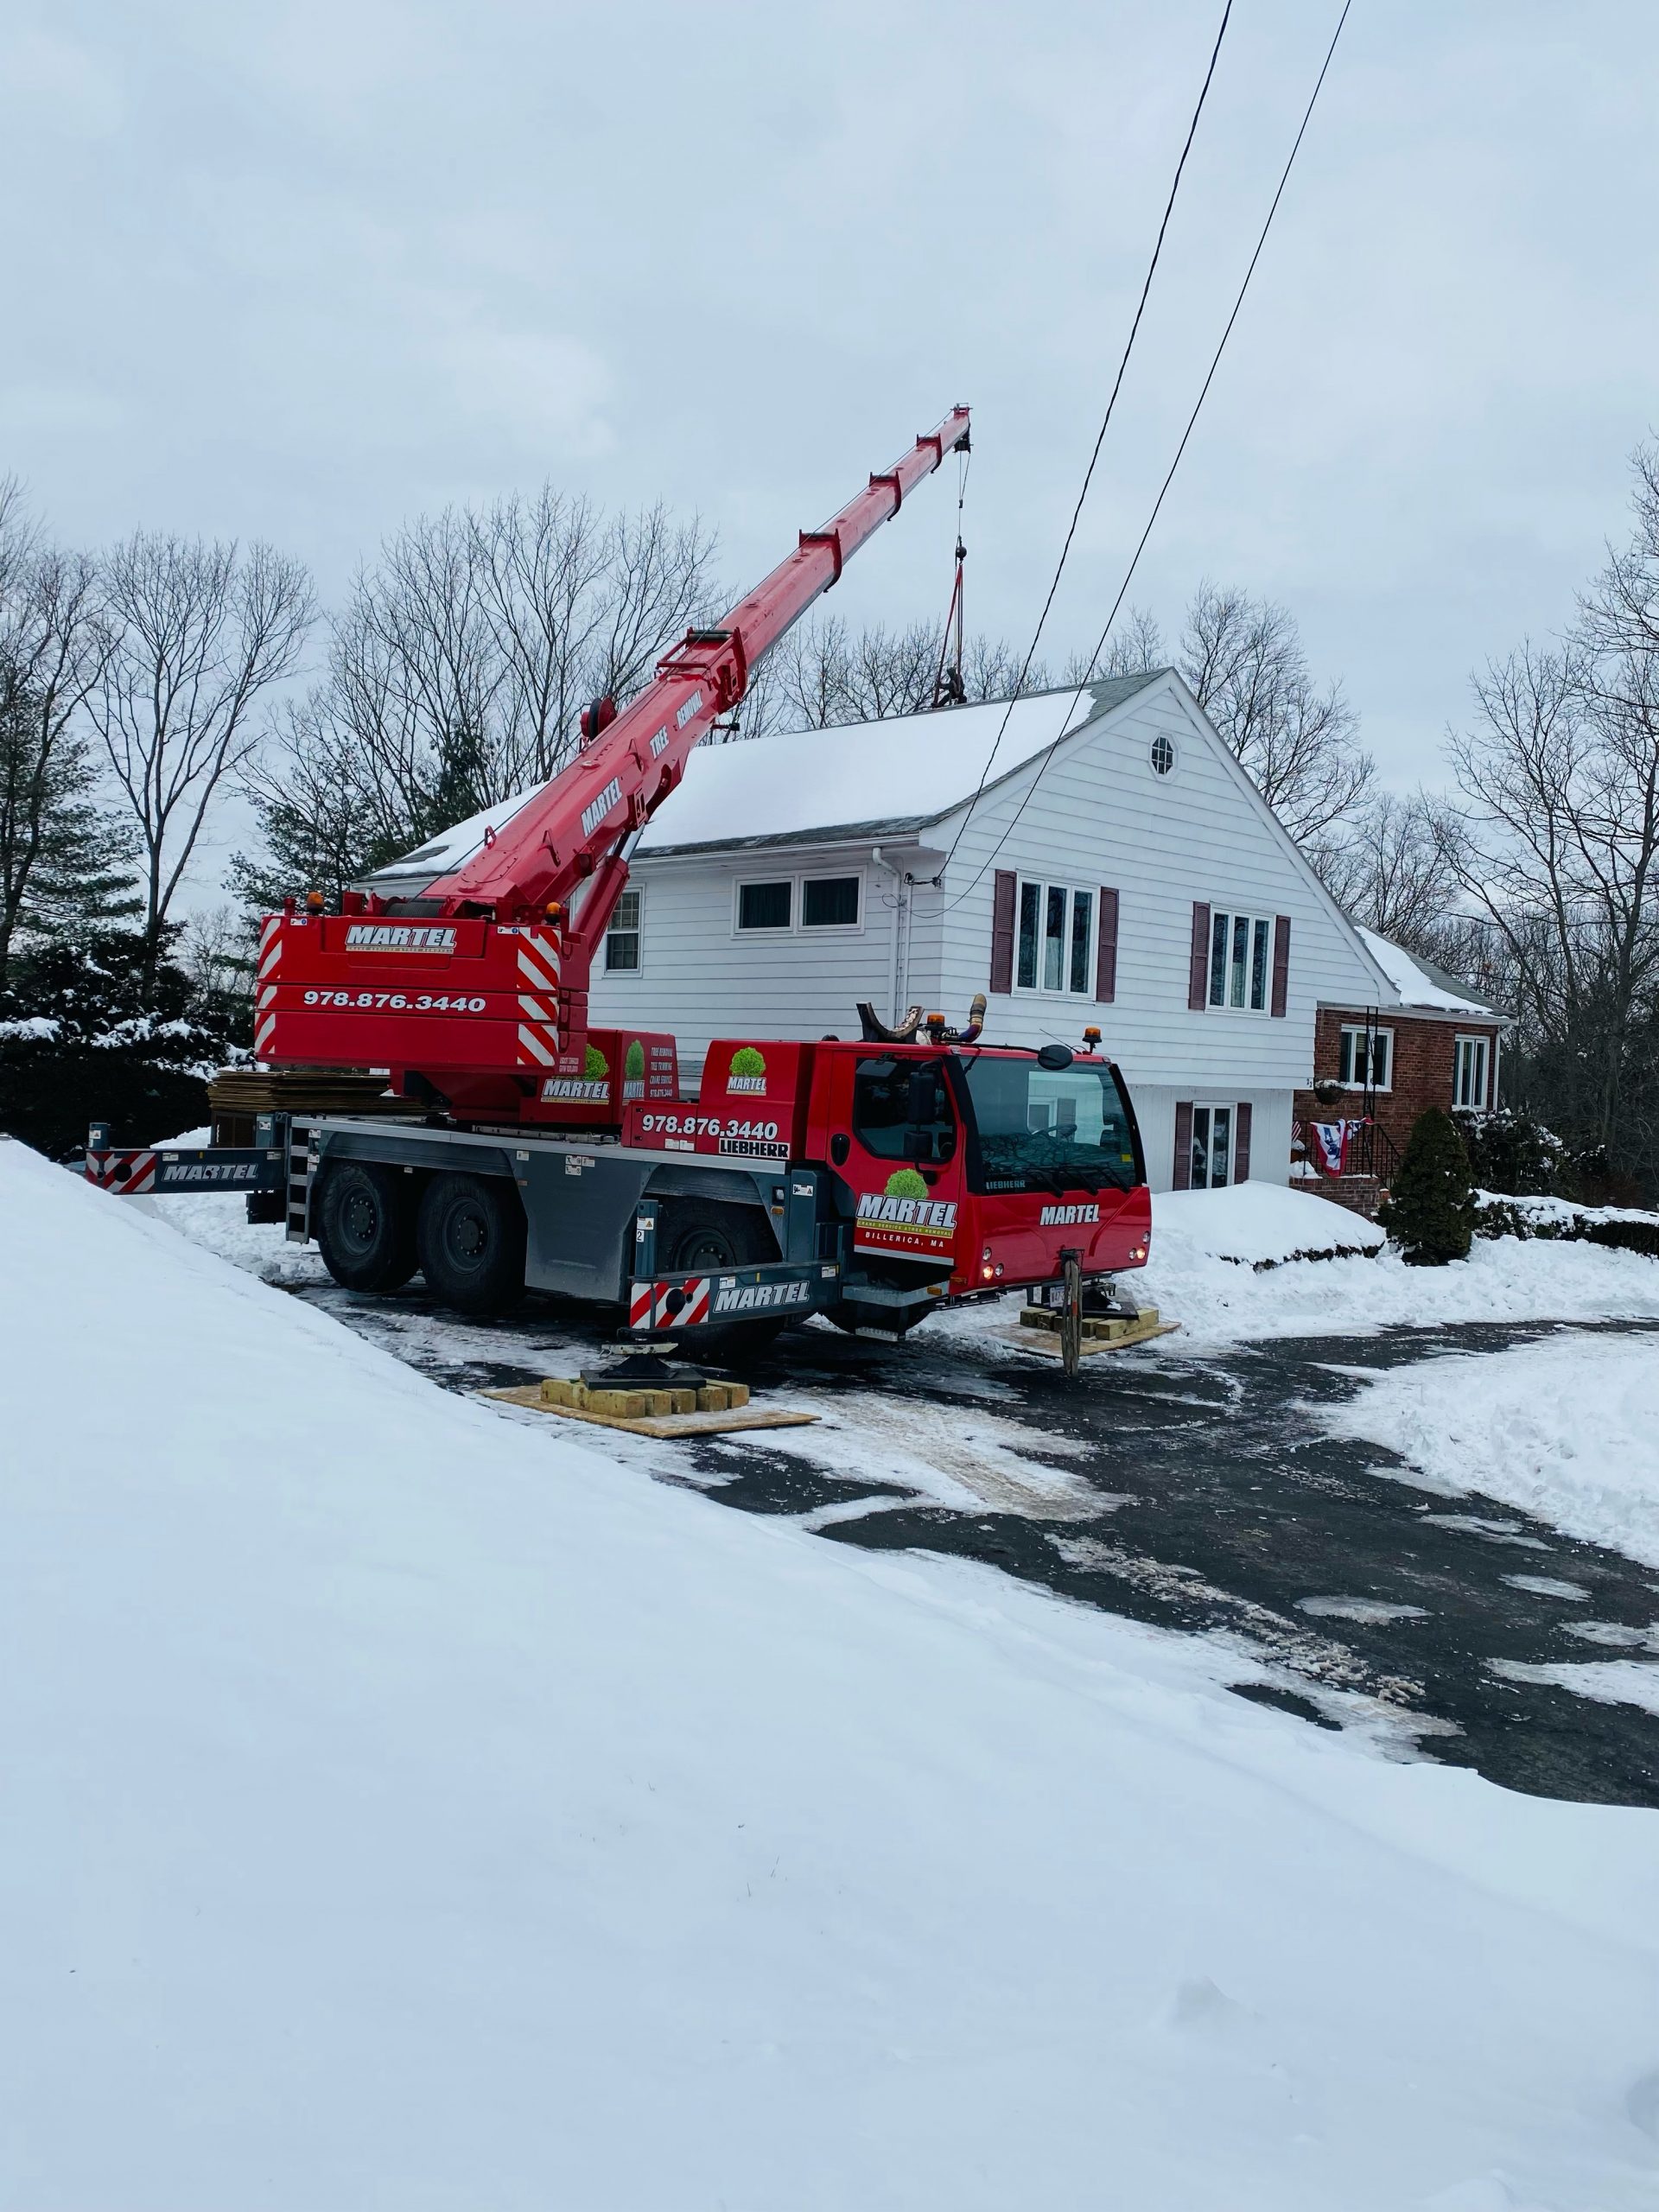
[367,671,1164,893]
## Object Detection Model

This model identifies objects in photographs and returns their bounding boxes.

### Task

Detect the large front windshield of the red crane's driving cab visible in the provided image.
[957,1055,1141,1192]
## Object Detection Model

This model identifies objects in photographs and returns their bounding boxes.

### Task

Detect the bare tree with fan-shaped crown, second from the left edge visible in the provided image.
[88,531,315,1004]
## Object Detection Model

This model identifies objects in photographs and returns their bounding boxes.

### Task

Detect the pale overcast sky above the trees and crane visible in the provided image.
[0,0,1659,854]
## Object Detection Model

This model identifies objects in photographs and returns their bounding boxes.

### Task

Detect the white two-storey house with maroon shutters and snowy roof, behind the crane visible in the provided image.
[570,671,1400,1188]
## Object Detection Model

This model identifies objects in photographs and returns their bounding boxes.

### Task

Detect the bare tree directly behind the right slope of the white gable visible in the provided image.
[1177,580,1376,842]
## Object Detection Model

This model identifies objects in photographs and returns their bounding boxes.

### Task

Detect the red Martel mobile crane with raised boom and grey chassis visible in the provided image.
[86,407,1150,1365]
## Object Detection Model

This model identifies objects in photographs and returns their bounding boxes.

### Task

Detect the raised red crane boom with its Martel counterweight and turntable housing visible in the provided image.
[254,407,969,1128]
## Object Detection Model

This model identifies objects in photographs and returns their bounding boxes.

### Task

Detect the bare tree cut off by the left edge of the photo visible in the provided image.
[0,498,122,987]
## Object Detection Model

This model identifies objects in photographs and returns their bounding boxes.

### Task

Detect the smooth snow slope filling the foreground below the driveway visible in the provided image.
[0,1144,1659,2212]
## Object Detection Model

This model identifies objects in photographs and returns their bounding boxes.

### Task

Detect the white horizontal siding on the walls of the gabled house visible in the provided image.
[593,677,1391,1190]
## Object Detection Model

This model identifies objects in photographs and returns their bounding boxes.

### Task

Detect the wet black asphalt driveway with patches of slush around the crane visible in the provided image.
[312,1289,1659,1805]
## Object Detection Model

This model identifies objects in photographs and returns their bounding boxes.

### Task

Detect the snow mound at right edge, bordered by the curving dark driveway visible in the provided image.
[1325,1327,1659,1566]
